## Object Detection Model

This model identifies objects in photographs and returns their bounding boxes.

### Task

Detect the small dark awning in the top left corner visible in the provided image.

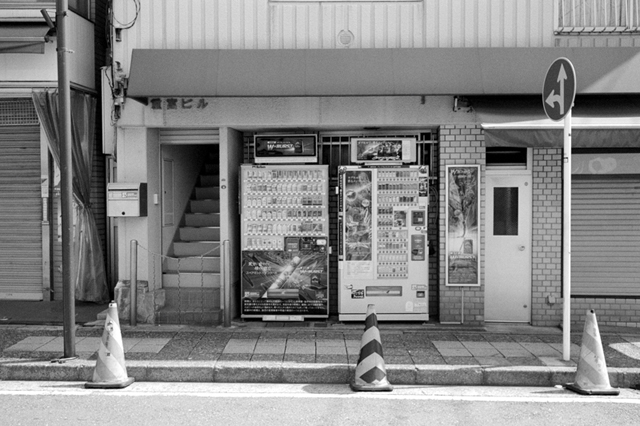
[0,22,49,53]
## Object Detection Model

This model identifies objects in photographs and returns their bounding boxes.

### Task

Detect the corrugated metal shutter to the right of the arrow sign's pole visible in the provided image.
[571,178,640,297]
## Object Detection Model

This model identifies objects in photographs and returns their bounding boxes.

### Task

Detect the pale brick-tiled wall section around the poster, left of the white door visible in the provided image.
[439,125,485,325]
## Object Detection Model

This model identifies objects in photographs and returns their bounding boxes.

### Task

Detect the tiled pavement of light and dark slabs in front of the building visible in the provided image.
[0,324,640,386]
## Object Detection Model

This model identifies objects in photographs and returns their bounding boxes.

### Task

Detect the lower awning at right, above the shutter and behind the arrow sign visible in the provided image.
[468,94,640,148]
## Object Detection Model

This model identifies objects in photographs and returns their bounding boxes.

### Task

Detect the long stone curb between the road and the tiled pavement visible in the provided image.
[0,359,640,388]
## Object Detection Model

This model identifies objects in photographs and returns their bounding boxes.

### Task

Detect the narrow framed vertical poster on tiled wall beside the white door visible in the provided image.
[446,165,480,286]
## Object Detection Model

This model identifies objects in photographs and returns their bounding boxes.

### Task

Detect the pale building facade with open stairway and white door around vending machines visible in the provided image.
[103,0,640,326]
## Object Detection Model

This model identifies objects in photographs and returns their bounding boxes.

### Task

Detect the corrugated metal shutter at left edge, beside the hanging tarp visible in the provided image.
[0,126,42,300]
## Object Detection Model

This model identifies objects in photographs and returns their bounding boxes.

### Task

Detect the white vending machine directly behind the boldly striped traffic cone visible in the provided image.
[338,138,429,321]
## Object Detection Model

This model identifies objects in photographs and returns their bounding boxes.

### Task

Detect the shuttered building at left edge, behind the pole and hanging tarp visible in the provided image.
[0,0,106,301]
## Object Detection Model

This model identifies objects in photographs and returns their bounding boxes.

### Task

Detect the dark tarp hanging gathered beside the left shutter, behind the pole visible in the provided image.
[33,89,109,303]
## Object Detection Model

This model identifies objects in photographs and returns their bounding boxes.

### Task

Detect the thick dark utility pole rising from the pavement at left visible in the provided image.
[56,0,76,358]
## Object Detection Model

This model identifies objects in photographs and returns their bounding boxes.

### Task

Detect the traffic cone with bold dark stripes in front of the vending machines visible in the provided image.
[351,305,393,391]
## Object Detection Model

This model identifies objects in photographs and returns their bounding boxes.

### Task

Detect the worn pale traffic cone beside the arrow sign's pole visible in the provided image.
[565,309,620,395]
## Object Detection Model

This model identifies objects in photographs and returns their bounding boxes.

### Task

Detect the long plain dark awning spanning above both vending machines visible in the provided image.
[127,47,640,102]
